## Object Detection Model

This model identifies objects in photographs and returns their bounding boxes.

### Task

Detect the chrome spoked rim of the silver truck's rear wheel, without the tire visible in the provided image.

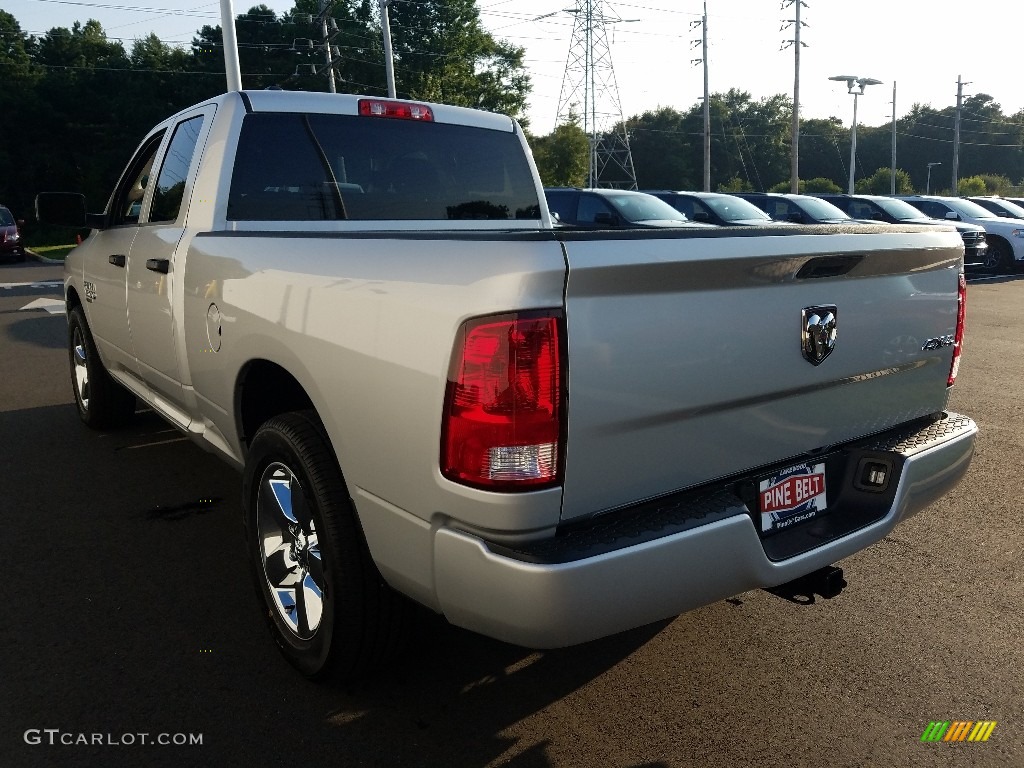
[256,462,326,640]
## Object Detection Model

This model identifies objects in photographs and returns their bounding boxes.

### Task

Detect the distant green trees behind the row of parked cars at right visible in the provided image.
[532,88,1024,195]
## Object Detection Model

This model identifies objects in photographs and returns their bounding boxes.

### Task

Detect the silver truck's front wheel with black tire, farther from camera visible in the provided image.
[68,306,135,430]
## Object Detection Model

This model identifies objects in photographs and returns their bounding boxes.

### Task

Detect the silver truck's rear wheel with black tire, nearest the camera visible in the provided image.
[243,412,409,681]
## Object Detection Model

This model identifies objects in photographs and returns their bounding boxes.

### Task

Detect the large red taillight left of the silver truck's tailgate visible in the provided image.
[441,312,564,490]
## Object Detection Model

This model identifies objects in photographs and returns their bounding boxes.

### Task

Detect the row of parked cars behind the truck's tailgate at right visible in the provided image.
[545,187,1024,272]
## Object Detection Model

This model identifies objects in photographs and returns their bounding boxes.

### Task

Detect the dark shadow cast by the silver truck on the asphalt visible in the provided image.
[6,403,668,768]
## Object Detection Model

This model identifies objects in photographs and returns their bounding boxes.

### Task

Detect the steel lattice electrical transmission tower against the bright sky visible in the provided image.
[555,0,637,189]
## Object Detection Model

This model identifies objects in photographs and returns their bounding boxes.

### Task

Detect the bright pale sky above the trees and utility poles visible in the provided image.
[8,0,1024,134]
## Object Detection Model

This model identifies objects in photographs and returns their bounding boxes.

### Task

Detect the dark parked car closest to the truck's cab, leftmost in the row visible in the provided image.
[544,186,710,228]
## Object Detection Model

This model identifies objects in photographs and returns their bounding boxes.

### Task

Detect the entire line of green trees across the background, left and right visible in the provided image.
[0,0,1024,231]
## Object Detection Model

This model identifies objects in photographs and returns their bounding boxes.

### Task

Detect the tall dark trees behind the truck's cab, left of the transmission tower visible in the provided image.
[0,0,529,227]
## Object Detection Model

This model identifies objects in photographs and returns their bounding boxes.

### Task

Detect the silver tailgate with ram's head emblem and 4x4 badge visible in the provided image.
[562,227,963,519]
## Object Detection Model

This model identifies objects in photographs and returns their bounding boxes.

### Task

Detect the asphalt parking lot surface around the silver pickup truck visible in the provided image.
[0,263,1024,768]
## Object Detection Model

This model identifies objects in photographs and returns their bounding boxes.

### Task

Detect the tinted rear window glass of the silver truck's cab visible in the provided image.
[227,114,541,221]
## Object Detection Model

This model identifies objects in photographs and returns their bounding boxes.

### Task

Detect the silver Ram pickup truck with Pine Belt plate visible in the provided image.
[37,91,977,677]
